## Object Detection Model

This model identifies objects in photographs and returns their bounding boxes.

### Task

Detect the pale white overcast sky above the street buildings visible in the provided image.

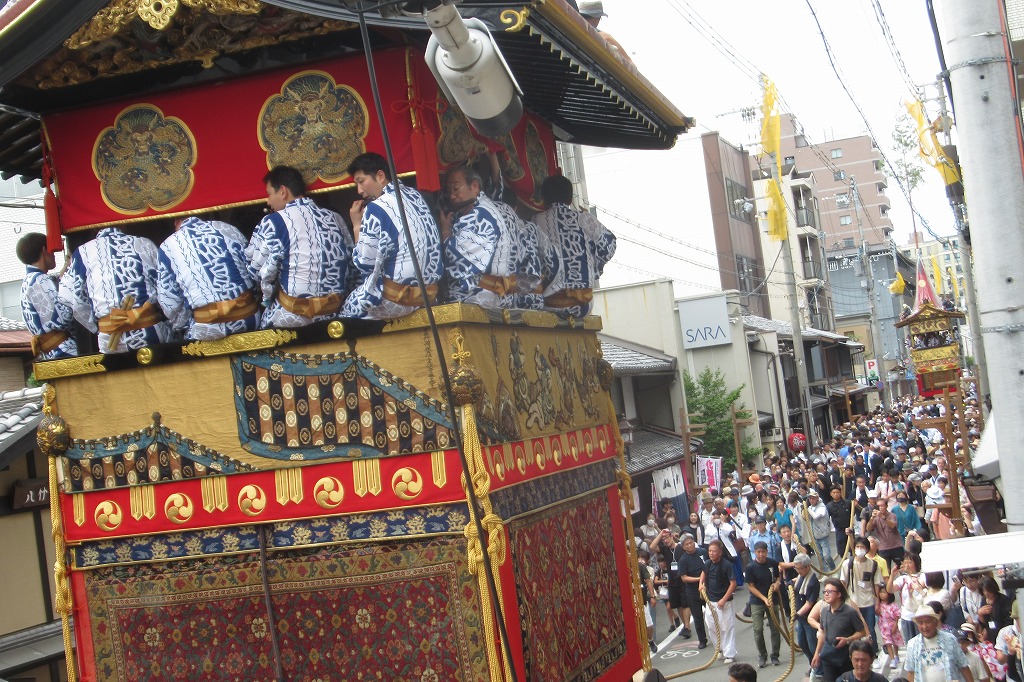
[585,0,954,295]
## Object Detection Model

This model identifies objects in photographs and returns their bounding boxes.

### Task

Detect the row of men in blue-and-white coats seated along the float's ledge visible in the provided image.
[17,153,615,359]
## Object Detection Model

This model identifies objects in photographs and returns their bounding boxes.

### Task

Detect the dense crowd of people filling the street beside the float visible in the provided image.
[636,396,1024,682]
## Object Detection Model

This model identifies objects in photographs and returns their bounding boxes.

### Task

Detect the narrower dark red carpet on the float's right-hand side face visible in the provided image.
[510,491,626,682]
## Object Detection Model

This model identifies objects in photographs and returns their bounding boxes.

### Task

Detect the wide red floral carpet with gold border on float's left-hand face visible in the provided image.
[85,537,488,682]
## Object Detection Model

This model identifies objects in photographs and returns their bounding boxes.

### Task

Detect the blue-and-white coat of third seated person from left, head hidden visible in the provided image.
[158,217,259,341]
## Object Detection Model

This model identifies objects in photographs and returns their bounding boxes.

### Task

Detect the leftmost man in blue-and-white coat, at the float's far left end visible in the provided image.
[16,232,78,360]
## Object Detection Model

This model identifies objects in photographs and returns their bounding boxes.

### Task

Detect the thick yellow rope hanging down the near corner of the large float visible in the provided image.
[459,404,512,680]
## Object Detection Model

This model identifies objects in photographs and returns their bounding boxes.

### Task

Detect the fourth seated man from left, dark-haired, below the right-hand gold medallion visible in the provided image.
[246,166,352,329]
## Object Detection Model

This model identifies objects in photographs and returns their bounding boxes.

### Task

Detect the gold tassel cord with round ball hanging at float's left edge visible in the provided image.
[36,386,78,682]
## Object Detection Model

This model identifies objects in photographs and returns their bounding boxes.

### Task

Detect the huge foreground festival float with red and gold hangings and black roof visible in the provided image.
[0,0,691,682]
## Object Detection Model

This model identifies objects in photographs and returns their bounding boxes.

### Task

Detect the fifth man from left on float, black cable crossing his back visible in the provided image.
[342,152,441,319]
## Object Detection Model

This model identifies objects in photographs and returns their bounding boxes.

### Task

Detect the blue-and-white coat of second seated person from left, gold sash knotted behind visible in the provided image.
[58,227,172,353]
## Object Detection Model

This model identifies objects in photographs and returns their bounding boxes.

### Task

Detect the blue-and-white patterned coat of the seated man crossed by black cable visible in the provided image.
[342,182,441,319]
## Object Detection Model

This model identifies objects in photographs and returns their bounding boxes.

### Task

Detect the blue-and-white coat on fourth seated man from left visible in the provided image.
[246,197,352,329]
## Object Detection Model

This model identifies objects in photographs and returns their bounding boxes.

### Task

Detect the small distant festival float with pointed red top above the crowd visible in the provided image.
[894,258,965,397]
